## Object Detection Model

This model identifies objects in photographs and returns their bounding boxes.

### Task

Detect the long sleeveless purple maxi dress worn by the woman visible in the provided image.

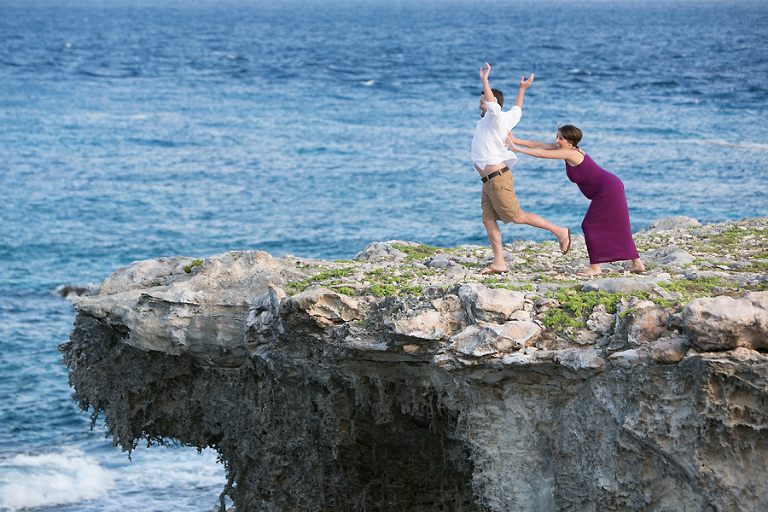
[565,154,639,264]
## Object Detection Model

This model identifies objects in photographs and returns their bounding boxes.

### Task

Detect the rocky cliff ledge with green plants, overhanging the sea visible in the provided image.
[61,218,768,512]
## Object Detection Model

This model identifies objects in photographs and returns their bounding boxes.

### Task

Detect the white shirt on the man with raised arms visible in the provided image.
[472,101,523,170]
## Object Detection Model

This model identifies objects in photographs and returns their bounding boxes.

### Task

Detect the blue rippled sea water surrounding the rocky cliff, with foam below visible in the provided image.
[0,0,768,512]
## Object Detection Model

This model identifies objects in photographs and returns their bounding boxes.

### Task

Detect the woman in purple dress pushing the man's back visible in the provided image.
[507,125,645,276]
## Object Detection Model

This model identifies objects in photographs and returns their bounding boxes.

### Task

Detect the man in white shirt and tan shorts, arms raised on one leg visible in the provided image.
[472,62,571,274]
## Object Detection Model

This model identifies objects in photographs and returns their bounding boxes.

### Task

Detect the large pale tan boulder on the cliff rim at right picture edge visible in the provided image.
[683,292,768,352]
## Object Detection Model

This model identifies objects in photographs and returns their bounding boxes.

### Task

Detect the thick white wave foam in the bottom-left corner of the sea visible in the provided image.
[0,449,115,511]
